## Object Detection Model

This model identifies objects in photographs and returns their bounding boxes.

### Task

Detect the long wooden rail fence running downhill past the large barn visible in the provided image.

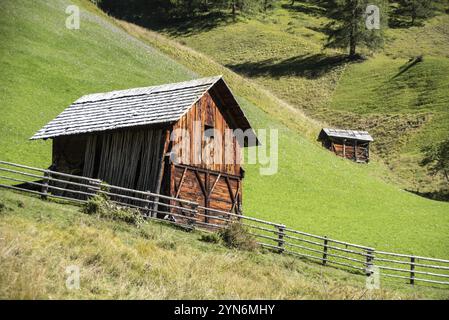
[0,161,449,287]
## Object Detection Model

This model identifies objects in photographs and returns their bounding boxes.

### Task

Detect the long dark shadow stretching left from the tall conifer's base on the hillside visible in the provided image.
[226,54,364,79]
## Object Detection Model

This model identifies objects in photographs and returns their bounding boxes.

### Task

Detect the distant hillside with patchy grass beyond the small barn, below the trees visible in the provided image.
[146,1,449,192]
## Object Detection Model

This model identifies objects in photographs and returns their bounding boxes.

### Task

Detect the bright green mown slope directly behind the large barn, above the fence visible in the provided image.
[0,0,449,257]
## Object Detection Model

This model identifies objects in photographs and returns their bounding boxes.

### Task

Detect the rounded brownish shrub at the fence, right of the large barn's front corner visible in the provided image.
[219,222,258,251]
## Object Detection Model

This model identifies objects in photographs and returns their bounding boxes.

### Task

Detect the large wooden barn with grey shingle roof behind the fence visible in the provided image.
[31,76,259,222]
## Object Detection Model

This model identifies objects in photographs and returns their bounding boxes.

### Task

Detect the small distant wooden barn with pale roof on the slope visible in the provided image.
[318,128,373,163]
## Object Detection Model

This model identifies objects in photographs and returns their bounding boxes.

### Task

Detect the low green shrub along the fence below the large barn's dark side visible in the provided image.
[82,194,144,227]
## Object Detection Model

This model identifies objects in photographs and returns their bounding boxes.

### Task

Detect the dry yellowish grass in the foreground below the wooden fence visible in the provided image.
[0,190,448,299]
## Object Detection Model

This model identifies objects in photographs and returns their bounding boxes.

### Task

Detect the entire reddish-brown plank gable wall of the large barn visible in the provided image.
[169,93,242,224]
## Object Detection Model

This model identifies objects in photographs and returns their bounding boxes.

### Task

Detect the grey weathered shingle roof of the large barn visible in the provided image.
[31,76,256,140]
